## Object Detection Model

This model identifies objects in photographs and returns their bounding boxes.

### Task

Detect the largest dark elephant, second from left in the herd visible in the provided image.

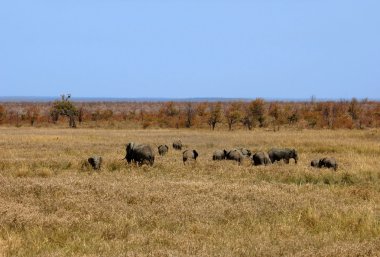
[124,142,154,166]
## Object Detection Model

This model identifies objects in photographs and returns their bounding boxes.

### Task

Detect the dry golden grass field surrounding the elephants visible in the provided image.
[0,127,380,256]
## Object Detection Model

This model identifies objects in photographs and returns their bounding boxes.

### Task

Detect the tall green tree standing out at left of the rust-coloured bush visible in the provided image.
[50,94,78,128]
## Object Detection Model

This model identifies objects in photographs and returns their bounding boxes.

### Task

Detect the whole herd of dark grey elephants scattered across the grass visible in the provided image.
[88,140,338,171]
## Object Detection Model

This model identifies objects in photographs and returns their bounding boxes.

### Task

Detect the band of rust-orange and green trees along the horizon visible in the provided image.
[0,95,380,131]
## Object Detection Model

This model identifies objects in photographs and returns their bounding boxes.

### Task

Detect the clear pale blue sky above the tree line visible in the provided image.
[0,0,380,99]
